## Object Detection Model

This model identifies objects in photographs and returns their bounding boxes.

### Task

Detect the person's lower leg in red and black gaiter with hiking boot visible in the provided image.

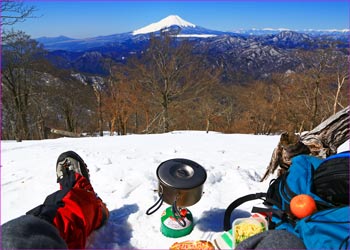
[28,151,109,248]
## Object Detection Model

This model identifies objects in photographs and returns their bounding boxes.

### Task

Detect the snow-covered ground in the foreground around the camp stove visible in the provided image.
[1,131,349,249]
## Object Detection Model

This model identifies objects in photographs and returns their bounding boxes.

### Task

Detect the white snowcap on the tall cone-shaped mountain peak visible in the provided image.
[133,15,196,35]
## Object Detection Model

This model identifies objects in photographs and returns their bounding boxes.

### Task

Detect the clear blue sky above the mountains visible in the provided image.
[14,0,349,38]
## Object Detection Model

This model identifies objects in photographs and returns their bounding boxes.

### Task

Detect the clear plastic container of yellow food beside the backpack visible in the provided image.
[232,214,268,248]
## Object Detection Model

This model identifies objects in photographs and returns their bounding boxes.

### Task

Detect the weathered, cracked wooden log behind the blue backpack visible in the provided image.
[260,106,350,181]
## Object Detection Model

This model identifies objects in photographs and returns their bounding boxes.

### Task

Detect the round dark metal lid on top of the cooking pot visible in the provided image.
[157,159,207,189]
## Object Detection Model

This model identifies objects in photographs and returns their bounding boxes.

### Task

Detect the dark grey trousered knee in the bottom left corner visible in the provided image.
[1,215,68,249]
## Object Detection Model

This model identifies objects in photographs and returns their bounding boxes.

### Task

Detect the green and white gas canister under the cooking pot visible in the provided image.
[160,207,193,238]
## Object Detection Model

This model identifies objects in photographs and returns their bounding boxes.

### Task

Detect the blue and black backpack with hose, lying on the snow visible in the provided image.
[224,151,350,249]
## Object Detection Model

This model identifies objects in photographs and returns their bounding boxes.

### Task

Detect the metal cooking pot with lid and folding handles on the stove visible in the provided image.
[146,159,207,226]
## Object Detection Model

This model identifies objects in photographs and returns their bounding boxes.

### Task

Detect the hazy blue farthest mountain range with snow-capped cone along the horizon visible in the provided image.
[36,15,349,51]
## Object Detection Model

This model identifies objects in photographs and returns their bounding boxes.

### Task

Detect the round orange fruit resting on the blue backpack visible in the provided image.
[290,194,317,219]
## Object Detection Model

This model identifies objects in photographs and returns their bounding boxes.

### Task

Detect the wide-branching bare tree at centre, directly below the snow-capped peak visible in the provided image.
[129,33,219,132]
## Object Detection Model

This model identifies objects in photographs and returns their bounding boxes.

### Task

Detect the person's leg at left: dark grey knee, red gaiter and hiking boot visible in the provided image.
[2,151,109,248]
